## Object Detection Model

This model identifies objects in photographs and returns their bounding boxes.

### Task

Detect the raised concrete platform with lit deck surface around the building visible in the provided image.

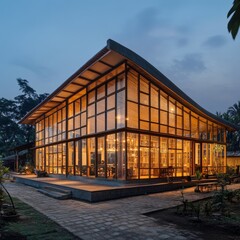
[14,175,206,203]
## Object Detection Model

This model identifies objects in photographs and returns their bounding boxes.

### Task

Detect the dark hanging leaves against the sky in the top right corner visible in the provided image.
[227,0,240,39]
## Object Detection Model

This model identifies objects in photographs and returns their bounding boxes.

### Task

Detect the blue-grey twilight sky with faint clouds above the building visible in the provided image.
[0,0,240,113]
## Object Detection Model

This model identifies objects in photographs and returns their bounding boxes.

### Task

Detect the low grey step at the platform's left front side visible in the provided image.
[38,186,72,200]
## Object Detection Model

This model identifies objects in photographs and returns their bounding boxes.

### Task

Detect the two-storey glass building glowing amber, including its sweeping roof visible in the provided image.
[21,40,234,180]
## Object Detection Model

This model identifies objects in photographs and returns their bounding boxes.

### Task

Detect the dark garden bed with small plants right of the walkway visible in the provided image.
[146,191,240,240]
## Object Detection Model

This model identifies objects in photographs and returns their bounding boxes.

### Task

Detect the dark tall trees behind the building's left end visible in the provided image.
[0,78,48,157]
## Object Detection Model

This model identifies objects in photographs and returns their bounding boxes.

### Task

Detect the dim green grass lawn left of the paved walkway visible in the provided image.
[0,198,79,240]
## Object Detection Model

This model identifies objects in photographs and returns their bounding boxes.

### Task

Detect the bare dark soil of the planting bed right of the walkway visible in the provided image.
[146,199,240,240]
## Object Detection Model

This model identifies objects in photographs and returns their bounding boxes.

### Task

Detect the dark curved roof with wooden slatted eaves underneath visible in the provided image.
[20,39,236,130]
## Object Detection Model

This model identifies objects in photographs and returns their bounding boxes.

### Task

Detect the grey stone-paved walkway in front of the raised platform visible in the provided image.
[5,182,240,240]
